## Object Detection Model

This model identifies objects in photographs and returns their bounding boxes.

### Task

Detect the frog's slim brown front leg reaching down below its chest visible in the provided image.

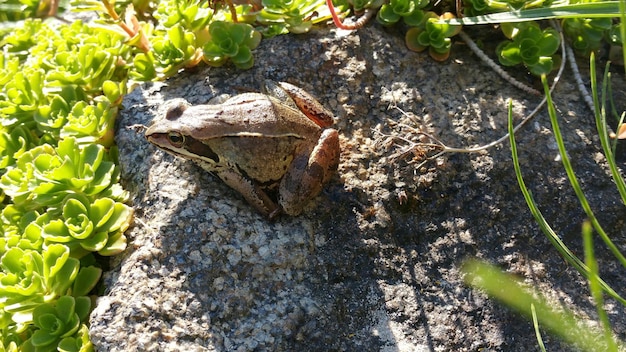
[215,169,280,219]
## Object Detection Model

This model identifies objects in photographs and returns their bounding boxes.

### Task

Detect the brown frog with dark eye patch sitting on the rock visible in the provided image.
[145,81,340,219]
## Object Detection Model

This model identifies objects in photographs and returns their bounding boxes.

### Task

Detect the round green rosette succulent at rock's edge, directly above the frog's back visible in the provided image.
[203,21,261,69]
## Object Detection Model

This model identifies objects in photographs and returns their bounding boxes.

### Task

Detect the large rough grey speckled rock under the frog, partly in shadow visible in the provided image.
[90,24,626,351]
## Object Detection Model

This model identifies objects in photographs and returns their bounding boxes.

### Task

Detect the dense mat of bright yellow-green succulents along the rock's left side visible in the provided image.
[0,6,137,351]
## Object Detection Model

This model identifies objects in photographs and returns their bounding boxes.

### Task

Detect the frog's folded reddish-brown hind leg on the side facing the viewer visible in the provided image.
[278,129,339,216]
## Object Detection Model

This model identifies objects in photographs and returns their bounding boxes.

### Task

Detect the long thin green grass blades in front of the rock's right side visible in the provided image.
[464,29,626,351]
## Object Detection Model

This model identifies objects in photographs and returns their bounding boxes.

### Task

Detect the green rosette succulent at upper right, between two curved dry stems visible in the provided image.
[496,22,561,76]
